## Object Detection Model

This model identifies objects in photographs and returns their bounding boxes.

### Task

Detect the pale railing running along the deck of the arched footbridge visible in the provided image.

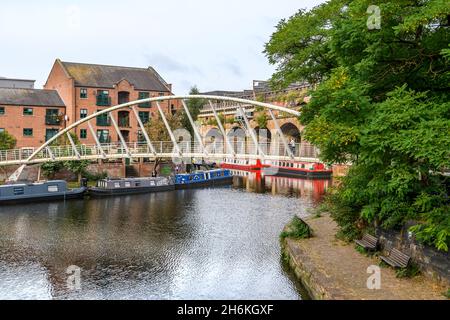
[0,141,319,165]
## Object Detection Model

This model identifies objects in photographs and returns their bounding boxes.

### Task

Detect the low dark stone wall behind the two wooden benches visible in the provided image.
[376,223,450,285]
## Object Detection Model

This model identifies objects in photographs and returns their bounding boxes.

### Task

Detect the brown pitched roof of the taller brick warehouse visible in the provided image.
[60,61,170,92]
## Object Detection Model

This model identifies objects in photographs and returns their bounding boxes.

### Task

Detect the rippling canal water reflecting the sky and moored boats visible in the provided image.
[0,173,329,299]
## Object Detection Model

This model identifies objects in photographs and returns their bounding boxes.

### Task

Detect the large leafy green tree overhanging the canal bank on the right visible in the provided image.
[266,0,450,251]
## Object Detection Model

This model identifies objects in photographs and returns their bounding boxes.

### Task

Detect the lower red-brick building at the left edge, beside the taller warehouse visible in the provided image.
[0,88,66,148]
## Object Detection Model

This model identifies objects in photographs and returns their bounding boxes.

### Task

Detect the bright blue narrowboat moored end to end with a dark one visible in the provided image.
[175,169,233,189]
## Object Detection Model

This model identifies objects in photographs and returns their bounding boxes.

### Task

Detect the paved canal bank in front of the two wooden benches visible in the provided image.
[281,215,447,300]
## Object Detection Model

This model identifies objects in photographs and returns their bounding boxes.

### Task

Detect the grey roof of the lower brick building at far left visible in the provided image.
[0,88,65,107]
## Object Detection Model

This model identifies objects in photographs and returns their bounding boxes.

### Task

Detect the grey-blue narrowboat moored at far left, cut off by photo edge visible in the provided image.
[0,180,87,204]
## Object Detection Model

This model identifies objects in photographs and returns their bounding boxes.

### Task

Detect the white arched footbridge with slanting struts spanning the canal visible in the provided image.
[0,95,317,180]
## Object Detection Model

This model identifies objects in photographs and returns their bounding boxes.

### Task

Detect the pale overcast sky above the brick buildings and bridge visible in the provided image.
[0,0,324,94]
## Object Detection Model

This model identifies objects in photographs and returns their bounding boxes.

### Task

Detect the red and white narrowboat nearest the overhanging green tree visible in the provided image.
[263,160,333,179]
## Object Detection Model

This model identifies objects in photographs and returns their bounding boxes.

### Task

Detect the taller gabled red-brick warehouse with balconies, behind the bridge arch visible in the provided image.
[44,59,179,144]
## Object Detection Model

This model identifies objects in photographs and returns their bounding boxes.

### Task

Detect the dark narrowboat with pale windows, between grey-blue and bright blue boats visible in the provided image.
[89,177,175,197]
